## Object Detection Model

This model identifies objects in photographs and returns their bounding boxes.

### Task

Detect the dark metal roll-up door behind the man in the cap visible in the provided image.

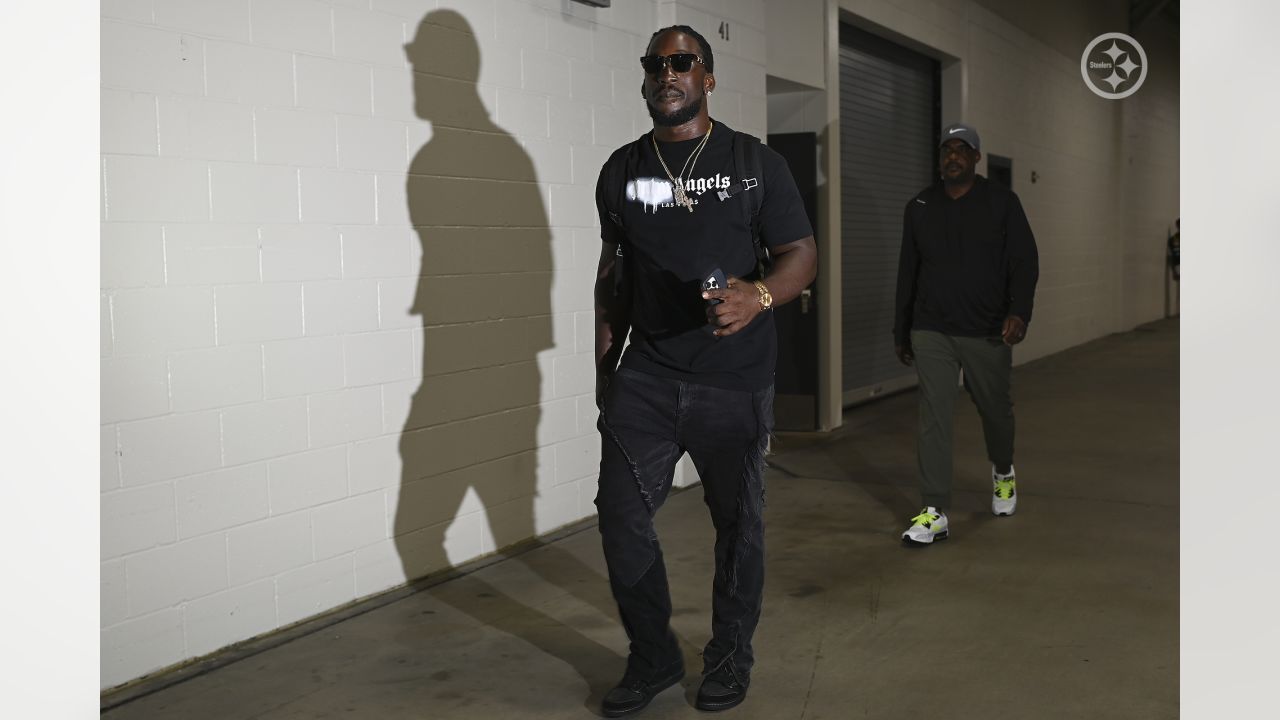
[840,24,940,406]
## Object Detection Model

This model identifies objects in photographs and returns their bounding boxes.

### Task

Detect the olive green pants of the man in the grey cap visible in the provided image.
[911,331,1014,510]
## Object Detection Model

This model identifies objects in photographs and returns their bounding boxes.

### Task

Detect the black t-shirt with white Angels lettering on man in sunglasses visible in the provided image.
[595,122,813,391]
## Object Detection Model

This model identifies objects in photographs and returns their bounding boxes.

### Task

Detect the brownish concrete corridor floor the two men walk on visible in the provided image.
[102,320,1179,720]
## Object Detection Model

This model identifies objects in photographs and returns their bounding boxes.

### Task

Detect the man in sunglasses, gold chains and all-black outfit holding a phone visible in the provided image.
[595,26,817,717]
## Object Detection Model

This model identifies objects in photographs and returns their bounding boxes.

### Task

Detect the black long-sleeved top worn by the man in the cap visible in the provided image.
[893,176,1039,345]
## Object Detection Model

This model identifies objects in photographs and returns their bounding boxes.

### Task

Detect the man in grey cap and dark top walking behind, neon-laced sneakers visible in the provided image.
[893,123,1039,544]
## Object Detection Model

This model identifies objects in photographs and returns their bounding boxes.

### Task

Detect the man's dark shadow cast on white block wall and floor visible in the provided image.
[394,9,623,706]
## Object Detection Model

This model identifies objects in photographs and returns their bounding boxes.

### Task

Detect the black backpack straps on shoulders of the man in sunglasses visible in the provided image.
[602,131,773,293]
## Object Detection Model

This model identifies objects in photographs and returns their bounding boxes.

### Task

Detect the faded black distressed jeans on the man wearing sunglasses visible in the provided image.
[595,369,773,682]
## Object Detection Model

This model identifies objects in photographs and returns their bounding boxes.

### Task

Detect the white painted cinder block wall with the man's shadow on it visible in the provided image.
[101,0,765,688]
